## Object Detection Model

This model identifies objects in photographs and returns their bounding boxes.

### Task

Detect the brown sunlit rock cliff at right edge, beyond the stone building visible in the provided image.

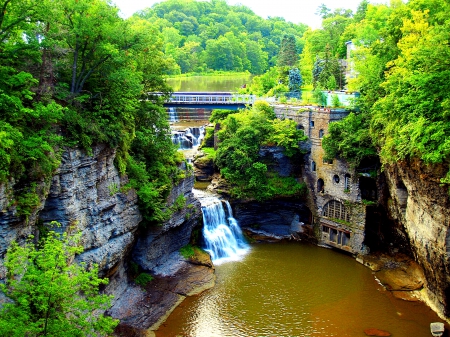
[385,161,450,317]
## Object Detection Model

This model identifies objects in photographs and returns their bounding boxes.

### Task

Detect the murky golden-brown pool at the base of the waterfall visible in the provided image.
[156,243,440,337]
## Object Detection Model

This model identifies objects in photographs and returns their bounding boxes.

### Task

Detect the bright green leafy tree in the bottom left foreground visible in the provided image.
[0,231,118,337]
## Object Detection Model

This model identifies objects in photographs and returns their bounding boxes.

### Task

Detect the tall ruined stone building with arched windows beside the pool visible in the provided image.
[274,106,370,254]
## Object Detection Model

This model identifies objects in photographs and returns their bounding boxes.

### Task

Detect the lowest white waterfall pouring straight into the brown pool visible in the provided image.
[200,197,250,264]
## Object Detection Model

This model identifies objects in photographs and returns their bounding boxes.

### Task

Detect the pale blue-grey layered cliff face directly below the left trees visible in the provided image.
[0,145,141,300]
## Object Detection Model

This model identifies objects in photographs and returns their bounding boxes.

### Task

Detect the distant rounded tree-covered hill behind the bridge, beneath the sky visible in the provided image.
[138,0,307,74]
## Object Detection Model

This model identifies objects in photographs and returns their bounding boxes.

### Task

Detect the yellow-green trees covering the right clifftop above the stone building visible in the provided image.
[316,0,450,183]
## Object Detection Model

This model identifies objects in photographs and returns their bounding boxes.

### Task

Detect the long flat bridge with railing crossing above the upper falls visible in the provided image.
[164,92,257,109]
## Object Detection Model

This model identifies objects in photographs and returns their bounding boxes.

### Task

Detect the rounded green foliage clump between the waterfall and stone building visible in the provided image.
[215,102,306,200]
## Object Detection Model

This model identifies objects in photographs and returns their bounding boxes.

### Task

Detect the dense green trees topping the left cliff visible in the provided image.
[0,0,183,221]
